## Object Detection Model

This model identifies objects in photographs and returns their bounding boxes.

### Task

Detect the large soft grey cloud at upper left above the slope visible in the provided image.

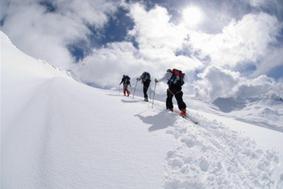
[1,0,117,69]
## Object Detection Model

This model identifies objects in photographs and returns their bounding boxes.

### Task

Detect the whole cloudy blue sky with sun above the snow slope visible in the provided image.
[0,0,283,100]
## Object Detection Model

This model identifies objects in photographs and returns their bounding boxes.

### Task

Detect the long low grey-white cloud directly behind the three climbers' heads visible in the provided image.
[74,39,200,88]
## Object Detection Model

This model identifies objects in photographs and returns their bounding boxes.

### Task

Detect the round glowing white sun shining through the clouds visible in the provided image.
[182,6,203,28]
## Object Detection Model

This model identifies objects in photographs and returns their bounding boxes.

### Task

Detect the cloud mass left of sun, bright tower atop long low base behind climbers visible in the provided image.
[76,4,203,87]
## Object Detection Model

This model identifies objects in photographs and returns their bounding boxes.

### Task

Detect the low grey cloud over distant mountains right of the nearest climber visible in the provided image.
[194,66,283,102]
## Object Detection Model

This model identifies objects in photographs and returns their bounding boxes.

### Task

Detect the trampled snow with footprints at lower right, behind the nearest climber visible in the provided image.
[165,113,282,189]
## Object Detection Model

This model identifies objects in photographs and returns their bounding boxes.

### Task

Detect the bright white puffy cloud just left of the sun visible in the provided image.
[130,4,187,59]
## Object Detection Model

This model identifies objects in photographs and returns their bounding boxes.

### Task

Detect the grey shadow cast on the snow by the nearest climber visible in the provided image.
[135,110,176,131]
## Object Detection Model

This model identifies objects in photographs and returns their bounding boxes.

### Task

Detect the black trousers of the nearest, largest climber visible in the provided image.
[166,85,187,110]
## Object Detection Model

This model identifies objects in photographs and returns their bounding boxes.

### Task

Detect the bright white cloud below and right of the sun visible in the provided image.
[189,13,280,68]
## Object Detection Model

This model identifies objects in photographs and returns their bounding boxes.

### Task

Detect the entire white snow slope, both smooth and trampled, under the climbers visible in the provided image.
[0,32,283,189]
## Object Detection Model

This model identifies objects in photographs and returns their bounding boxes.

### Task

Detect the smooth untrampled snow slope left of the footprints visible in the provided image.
[1,31,176,189]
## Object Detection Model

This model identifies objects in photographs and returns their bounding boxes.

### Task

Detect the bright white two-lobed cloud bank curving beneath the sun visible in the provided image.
[130,4,282,77]
